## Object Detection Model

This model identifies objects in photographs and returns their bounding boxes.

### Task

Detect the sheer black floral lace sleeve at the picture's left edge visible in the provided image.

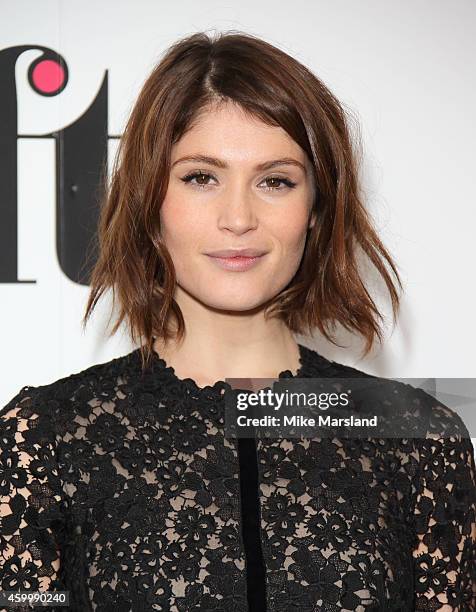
[0,387,67,612]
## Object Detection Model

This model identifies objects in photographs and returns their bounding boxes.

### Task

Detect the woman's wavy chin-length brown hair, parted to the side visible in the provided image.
[83,30,402,367]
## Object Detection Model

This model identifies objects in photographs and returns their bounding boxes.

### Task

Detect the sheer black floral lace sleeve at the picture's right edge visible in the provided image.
[413,396,476,612]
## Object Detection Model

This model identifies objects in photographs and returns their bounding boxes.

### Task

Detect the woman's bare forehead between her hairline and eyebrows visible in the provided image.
[172,102,306,163]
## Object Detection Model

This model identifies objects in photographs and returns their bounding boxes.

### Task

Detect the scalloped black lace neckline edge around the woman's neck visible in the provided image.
[143,342,316,402]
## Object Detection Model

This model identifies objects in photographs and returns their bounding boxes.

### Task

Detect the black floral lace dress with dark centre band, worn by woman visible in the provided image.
[0,345,476,612]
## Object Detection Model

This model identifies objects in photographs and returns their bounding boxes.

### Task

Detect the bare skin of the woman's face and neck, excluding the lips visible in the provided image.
[154,103,315,387]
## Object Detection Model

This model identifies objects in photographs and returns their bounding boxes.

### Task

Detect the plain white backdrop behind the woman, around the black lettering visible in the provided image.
[0,0,476,450]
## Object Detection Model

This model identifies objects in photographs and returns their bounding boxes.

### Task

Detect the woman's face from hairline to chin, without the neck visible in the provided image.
[160,103,314,312]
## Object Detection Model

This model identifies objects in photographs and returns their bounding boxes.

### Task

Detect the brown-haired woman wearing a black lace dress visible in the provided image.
[1,32,476,612]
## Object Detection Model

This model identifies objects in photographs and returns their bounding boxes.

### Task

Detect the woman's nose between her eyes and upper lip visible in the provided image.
[217,183,258,234]
